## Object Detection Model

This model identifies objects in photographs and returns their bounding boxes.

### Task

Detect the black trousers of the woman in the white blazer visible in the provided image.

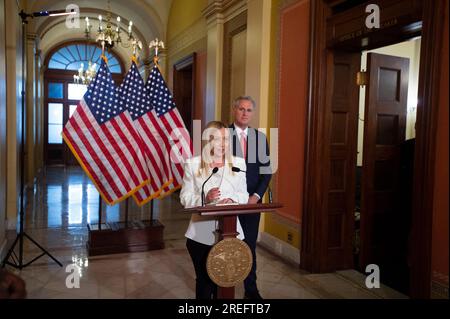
[186,238,217,299]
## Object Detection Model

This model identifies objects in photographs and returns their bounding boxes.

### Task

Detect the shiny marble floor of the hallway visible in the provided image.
[2,167,406,299]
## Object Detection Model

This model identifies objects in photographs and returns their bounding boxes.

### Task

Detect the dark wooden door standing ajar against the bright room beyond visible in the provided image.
[360,53,409,285]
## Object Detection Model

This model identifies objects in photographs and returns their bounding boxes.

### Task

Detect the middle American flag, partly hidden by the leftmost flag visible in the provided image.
[119,61,172,205]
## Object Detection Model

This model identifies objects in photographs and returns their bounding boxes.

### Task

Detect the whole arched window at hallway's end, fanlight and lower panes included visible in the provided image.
[44,41,124,165]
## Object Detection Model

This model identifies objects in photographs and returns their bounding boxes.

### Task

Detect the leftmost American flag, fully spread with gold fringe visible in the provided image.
[62,59,150,205]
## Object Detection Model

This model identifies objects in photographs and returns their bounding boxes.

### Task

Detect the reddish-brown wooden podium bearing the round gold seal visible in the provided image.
[183,203,283,299]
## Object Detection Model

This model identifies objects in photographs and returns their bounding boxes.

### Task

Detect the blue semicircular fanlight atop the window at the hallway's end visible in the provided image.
[48,43,122,73]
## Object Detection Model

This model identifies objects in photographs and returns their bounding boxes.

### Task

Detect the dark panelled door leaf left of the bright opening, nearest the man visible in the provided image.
[322,51,361,271]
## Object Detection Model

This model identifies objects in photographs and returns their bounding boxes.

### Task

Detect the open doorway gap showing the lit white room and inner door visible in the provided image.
[354,37,421,294]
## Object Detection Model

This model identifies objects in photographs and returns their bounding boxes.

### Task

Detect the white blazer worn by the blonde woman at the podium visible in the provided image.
[180,156,249,246]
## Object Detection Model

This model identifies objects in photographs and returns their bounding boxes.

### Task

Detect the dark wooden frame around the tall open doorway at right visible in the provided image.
[300,0,445,298]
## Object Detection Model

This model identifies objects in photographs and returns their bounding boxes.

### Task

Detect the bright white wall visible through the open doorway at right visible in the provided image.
[357,38,421,166]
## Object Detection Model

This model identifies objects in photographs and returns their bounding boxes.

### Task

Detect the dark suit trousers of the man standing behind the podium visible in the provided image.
[239,213,261,294]
